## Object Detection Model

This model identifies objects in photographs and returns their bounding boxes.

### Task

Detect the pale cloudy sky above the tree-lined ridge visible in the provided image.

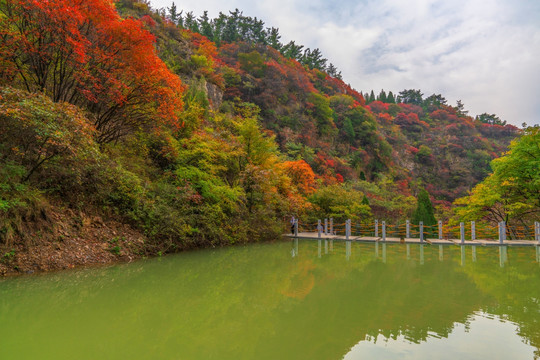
[150,0,540,127]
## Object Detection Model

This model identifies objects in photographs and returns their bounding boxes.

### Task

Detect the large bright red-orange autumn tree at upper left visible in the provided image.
[0,0,183,142]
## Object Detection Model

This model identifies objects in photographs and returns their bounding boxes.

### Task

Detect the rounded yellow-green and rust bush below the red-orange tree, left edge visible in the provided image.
[0,87,100,195]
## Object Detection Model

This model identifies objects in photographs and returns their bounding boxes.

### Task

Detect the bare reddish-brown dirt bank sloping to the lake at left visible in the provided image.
[0,209,146,276]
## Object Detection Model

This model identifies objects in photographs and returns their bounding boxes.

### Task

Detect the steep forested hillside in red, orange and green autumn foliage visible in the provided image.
[0,0,538,272]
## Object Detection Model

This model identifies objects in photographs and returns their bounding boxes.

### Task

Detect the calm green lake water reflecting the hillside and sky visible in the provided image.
[0,240,540,360]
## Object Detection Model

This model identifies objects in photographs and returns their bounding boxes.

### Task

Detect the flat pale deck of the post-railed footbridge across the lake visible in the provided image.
[283,232,540,246]
